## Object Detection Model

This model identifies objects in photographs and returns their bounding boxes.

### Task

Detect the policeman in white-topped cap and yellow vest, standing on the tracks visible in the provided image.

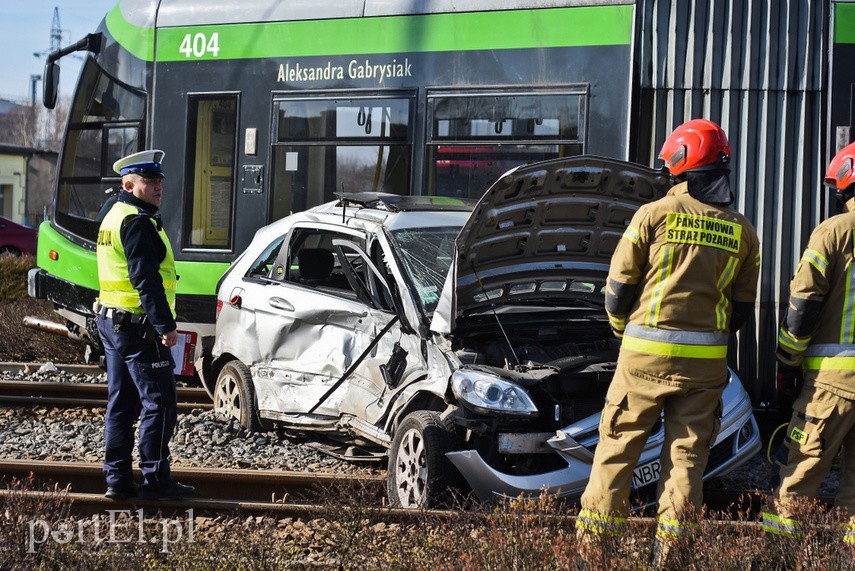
[96,150,195,500]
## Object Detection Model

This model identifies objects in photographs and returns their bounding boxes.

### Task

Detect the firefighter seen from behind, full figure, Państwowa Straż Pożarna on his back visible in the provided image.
[576,119,760,564]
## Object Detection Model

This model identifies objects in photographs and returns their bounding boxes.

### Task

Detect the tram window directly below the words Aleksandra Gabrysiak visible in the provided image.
[271,96,413,220]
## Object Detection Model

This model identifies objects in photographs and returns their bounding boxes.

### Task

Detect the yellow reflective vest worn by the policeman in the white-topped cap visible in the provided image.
[95,202,177,317]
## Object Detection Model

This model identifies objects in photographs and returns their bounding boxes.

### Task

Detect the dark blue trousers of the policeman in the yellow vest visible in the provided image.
[98,315,178,487]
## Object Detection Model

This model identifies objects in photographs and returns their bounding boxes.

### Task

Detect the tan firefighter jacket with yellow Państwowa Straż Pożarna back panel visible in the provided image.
[606,183,760,385]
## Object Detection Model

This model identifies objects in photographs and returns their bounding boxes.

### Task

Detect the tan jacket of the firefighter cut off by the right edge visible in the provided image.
[778,199,855,399]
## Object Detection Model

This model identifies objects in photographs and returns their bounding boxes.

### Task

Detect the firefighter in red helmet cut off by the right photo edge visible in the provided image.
[763,143,855,544]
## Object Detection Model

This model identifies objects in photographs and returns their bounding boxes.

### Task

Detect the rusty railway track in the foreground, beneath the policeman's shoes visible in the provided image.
[0,460,772,527]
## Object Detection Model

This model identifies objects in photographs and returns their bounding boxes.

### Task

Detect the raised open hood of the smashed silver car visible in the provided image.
[431,155,671,333]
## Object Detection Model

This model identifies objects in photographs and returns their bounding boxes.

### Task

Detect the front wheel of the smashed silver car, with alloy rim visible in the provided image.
[386,410,459,509]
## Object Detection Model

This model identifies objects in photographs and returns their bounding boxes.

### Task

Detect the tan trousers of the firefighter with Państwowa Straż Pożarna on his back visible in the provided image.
[582,367,726,524]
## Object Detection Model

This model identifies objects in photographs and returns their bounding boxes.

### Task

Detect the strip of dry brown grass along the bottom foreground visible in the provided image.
[0,482,852,571]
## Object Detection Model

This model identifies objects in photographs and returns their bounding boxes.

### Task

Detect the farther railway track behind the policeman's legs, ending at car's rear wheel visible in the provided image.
[0,381,214,412]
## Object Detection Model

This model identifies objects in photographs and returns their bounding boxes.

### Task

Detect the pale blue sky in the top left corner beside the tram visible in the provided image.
[0,0,118,102]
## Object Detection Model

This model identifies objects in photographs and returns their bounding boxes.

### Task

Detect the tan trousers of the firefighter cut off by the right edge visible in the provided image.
[776,383,855,517]
